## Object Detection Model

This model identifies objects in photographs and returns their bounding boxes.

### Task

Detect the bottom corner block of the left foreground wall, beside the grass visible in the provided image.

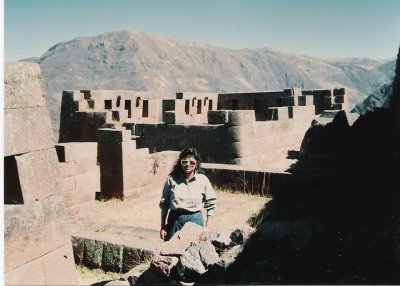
[42,241,78,285]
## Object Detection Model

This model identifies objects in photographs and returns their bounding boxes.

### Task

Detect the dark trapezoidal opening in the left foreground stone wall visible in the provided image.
[4,156,24,205]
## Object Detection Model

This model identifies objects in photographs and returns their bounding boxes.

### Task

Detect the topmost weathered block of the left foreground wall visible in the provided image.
[4,62,46,109]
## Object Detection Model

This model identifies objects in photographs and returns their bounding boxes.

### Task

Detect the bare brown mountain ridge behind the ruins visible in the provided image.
[26,30,394,138]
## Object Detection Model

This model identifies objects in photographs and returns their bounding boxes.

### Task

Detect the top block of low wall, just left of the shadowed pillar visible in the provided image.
[55,142,97,162]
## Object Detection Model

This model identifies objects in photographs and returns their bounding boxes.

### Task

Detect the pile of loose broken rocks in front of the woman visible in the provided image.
[113,222,255,285]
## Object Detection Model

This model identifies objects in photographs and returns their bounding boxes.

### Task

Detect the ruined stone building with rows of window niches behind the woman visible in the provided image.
[60,88,348,166]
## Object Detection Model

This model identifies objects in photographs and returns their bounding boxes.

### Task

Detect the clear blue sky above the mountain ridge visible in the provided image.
[4,0,400,61]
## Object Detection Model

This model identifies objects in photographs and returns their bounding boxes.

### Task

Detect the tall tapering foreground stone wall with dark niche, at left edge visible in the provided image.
[4,63,77,285]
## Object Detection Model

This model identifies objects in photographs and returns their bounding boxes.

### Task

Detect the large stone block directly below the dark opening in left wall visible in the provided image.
[4,195,70,271]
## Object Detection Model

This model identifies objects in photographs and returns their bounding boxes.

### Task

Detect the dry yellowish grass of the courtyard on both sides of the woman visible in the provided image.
[75,190,267,231]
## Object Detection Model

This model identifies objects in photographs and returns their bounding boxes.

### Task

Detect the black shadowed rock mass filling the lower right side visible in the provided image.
[225,46,400,284]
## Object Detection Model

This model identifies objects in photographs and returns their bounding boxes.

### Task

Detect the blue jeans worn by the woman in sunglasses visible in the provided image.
[167,210,204,240]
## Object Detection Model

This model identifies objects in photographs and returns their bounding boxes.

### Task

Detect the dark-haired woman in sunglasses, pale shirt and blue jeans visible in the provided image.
[160,148,217,240]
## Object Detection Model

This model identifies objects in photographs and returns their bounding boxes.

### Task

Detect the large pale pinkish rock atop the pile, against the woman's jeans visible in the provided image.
[159,222,204,256]
